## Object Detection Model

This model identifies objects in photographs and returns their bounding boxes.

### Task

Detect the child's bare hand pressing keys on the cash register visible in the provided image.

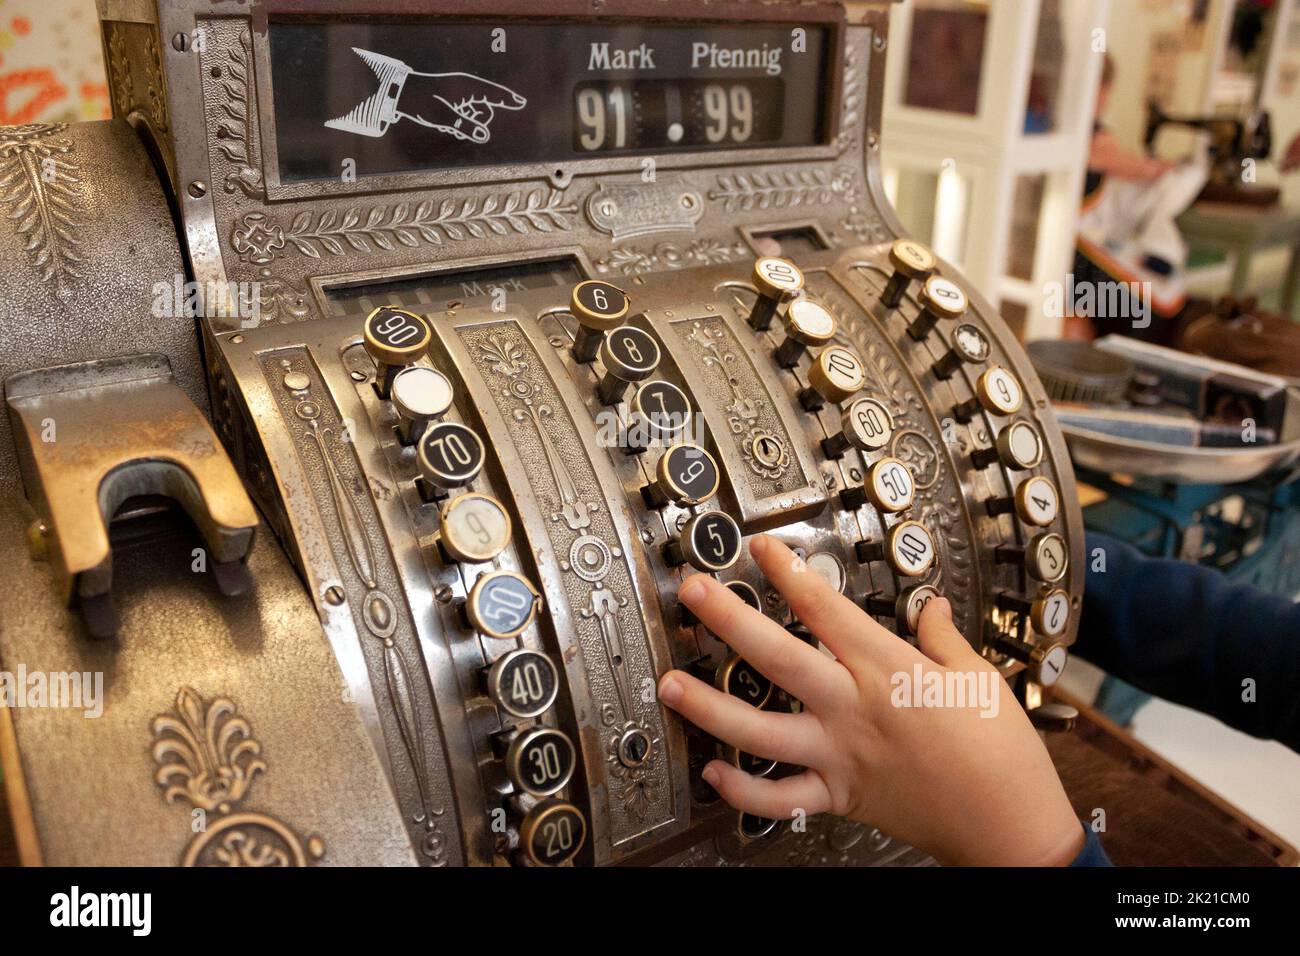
[659,535,1083,865]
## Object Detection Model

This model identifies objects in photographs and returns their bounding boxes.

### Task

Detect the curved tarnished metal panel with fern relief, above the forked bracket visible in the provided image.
[0,121,208,481]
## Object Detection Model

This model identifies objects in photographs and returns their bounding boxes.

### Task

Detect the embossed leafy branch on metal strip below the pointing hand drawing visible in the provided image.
[285,189,577,259]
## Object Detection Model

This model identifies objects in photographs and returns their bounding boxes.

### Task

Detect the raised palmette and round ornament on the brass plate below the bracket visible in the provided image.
[152,687,325,866]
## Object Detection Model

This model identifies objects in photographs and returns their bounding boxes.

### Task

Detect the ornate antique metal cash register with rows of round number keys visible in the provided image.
[0,0,1083,866]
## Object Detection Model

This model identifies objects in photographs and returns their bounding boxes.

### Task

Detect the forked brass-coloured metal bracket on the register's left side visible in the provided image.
[5,354,257,637]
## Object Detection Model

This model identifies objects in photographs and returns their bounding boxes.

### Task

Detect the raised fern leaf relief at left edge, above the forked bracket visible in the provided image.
[0,124,85,294]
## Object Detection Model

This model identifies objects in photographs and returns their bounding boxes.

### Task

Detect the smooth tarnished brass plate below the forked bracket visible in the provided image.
[0,493,415,866]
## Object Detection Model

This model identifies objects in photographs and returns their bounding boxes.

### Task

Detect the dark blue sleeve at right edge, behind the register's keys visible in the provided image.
[1074,532,1300,750]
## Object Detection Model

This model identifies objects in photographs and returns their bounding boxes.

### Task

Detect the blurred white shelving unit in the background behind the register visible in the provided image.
[883,0,1109,339]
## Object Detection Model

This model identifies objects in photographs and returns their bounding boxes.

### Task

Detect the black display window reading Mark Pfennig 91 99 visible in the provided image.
[269,21,829,182]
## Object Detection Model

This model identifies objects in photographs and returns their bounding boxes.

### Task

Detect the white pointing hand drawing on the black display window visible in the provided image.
[325,47,528,143]
